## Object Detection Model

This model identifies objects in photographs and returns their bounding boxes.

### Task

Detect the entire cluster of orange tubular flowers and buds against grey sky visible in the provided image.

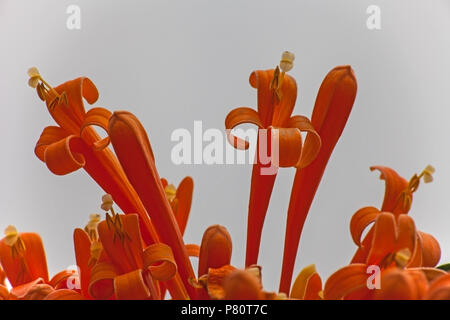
[0,52,450,300]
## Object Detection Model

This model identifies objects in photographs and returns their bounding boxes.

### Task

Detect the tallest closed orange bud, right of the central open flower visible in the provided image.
[280,66,357,293]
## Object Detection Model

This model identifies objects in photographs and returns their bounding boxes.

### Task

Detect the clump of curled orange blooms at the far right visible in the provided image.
[316,166,446,300]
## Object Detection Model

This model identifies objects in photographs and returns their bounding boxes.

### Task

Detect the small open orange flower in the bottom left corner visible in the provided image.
[0,226,82,300]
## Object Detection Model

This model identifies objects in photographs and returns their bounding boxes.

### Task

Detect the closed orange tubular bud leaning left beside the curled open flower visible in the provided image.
[108,111,195,298]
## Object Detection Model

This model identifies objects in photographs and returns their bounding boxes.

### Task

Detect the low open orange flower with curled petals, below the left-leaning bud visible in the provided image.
[74,195,188,300]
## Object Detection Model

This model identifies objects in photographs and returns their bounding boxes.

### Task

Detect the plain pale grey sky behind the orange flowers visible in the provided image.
[0,0,450,290]
